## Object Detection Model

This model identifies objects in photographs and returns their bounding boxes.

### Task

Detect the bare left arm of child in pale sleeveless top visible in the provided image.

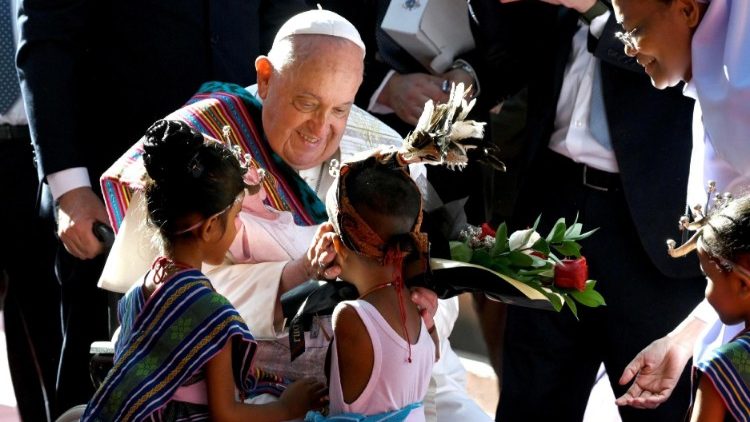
[333,306,375,403]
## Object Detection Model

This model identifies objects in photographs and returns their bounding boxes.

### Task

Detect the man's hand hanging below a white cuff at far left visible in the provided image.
[57,187,109,259]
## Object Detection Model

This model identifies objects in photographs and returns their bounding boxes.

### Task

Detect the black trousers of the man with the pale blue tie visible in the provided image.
[496,149,705,422]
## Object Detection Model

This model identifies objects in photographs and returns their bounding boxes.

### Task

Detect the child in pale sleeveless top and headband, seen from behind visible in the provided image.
[308,156,437,421]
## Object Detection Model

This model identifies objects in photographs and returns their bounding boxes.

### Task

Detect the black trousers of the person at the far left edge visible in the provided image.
[0,137,62,421]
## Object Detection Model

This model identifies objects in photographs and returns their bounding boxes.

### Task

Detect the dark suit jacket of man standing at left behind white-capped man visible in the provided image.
[18,0,307,189]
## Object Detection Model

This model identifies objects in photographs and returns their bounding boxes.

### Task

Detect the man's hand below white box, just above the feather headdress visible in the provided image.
[378,73,448,125]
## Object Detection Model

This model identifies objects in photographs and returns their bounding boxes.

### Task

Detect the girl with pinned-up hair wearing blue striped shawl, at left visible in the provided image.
[82,120,325,421]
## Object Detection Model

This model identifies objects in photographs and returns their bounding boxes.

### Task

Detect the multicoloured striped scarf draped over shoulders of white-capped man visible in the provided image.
[101,82,328,230]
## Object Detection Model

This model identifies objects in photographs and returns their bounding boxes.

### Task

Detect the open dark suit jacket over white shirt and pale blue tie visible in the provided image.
[497,2,699,277]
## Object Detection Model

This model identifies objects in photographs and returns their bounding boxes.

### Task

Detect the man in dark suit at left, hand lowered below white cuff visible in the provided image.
[17,0,307,413]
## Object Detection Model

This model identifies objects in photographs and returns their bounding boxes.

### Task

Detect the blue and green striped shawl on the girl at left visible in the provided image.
[81,269,256,421]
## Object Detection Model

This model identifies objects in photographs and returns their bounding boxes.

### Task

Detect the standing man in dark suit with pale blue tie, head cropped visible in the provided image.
[496,0,704,421]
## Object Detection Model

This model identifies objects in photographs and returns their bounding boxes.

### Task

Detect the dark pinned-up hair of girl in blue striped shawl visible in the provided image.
[143,120,245,249]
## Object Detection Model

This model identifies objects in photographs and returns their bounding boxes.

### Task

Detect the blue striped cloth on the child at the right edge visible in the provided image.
[696,331,750,421]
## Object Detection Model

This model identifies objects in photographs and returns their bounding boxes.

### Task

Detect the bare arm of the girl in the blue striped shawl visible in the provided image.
[206,342,325,421]
